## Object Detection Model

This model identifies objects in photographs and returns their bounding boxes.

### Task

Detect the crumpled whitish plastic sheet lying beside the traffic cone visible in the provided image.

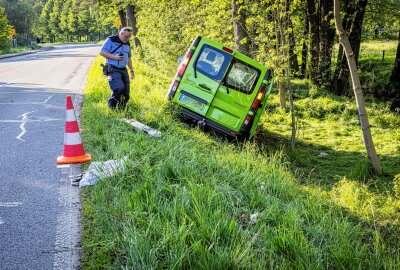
[79,157,128,188]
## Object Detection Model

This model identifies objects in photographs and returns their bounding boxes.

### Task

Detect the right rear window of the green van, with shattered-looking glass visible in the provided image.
[226,59,261,94]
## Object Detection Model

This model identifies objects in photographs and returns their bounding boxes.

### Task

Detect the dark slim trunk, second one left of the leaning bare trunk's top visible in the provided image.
[307,0,320,85]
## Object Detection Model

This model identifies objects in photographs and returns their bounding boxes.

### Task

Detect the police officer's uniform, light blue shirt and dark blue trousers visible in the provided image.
[101,35,132,109]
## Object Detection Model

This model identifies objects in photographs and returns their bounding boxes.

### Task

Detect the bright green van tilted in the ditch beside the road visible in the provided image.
[168,36,273,139]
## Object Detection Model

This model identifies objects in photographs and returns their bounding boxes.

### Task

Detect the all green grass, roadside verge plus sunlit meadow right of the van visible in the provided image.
[82,56,400,269]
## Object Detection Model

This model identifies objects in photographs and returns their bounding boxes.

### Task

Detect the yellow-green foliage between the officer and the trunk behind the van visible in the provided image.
[136,0,233,74]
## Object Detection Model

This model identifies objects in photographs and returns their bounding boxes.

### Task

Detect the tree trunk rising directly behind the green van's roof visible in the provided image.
[232,0,250,55]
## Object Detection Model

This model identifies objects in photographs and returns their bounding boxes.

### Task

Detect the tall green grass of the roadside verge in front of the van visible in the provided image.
[82,56,400,269]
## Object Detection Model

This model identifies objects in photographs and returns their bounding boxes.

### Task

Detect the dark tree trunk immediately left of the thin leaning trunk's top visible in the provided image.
[318,0,335,89]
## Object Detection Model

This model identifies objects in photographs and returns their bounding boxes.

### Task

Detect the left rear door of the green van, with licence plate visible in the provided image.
[174,42,233,116]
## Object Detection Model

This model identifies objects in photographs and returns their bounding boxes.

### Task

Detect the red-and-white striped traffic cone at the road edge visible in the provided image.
[57,96,92,164]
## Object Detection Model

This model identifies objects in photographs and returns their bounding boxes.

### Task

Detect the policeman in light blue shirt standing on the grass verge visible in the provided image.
[100,27,135,110]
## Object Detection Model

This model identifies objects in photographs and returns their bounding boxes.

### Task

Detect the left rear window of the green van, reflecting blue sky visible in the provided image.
[196,45,232,81]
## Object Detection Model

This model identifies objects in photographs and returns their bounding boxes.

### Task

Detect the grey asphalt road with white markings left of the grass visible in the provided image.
[0,45,100,269]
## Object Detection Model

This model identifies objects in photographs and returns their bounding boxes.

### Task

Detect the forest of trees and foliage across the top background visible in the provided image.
[0,0,400,105]
